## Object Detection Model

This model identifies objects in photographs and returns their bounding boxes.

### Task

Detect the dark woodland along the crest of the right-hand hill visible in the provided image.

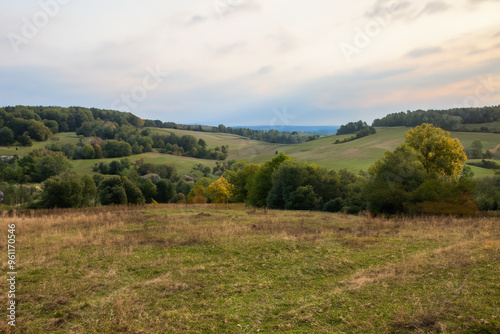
[373,105,500,133]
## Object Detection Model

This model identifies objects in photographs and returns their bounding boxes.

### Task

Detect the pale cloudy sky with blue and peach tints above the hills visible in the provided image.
[0,0,500,127]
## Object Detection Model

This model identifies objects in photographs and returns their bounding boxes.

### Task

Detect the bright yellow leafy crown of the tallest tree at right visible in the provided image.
[405,123,467,177]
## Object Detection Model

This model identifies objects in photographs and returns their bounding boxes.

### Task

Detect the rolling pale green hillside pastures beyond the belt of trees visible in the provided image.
[0,127,500,177]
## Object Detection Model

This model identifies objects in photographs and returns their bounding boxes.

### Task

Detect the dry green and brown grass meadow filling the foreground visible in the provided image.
[0,205,500,333]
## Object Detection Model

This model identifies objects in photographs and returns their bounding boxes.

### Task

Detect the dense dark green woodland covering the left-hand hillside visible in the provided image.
[0,106,228,160]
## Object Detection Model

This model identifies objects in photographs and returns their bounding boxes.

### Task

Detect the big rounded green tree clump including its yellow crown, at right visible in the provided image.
[367,124,477,214]
